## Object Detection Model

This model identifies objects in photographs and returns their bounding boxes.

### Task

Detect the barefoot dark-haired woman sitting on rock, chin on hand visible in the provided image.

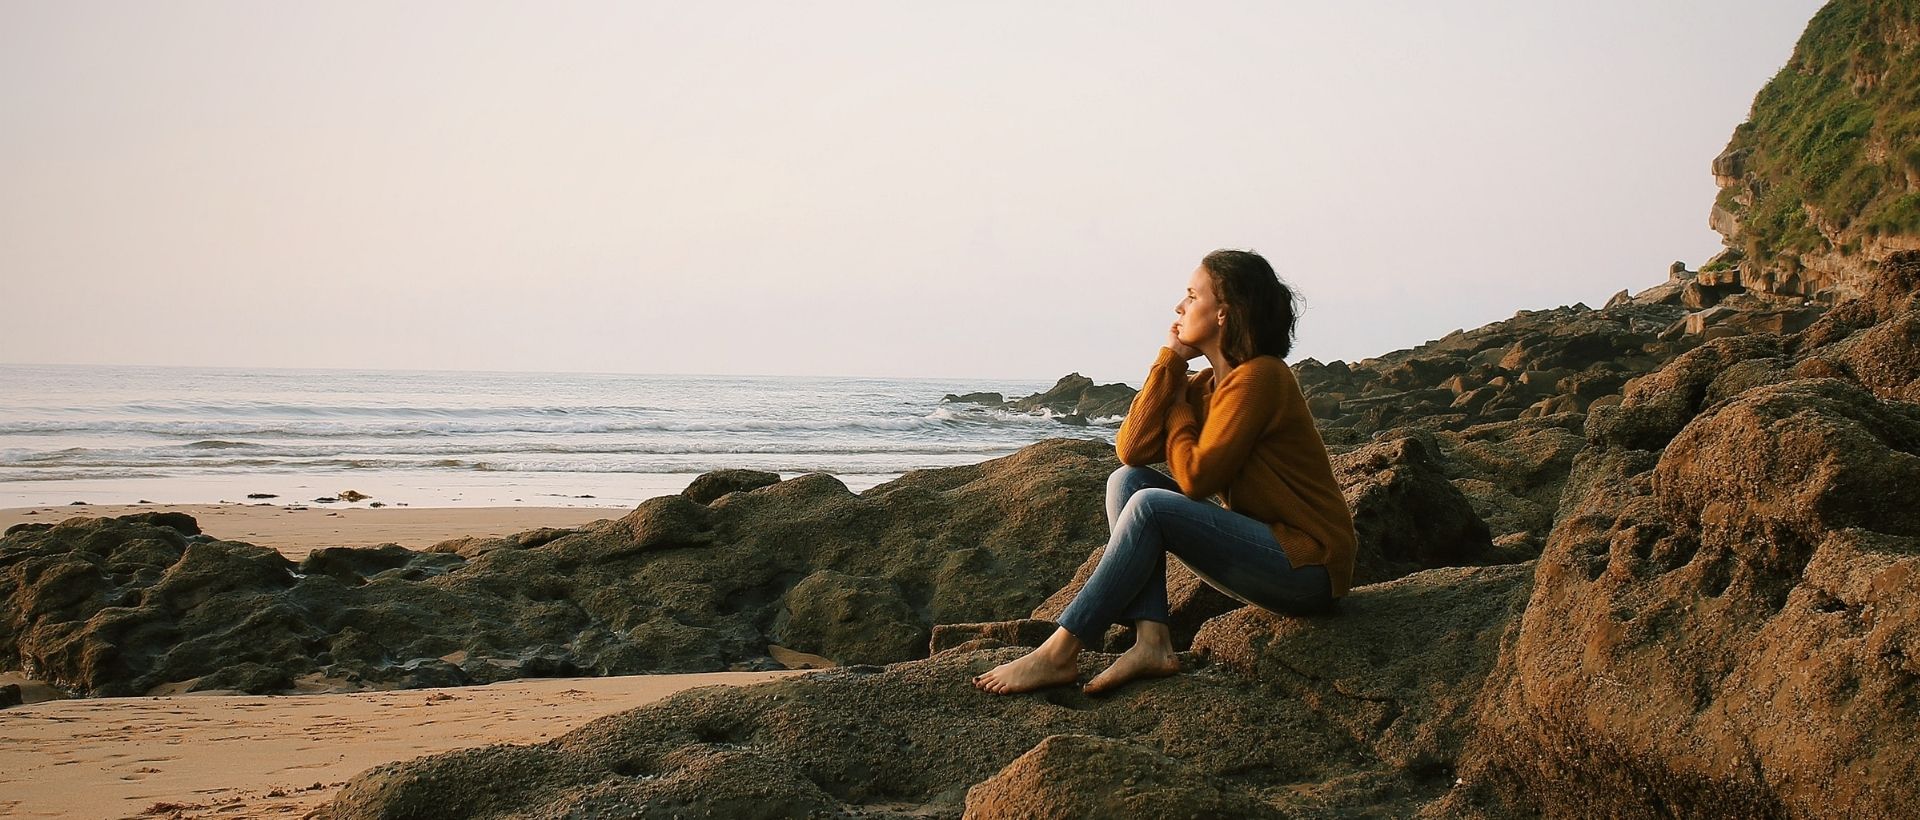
[973,250,1354,695]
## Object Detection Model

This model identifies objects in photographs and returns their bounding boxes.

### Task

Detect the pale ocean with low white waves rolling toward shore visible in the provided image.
[0,365,1119,507]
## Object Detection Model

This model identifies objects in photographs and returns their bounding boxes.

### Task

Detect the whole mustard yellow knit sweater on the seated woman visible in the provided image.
[1116,348,1356,597]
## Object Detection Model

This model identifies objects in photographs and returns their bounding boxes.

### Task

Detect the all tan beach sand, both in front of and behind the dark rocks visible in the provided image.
[0,503,818,818]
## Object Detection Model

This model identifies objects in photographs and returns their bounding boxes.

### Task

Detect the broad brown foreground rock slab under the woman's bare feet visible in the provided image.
[321,565,1532,818]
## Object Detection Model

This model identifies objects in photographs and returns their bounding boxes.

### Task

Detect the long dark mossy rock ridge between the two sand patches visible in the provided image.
[0,440,1119,695]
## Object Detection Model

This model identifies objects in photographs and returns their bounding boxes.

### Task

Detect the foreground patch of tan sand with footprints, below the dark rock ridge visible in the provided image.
[0,672,799,818]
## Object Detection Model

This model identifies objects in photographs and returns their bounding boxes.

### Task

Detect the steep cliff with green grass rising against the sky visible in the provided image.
[1701,0,1920,301]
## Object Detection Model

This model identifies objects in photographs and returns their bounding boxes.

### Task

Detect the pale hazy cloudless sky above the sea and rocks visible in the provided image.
[0,0,1820,386]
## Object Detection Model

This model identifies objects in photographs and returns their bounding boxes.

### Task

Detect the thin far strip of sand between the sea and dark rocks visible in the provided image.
[0,503,628,561]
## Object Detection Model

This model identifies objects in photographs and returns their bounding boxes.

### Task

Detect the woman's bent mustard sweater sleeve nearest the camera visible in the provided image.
[1167,367,1281,499]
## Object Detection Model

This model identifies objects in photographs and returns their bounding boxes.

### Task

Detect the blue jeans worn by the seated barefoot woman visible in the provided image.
[1060,467,1332,647]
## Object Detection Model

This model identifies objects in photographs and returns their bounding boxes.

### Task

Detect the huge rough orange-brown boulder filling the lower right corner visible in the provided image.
[1467,376,1920,818]
